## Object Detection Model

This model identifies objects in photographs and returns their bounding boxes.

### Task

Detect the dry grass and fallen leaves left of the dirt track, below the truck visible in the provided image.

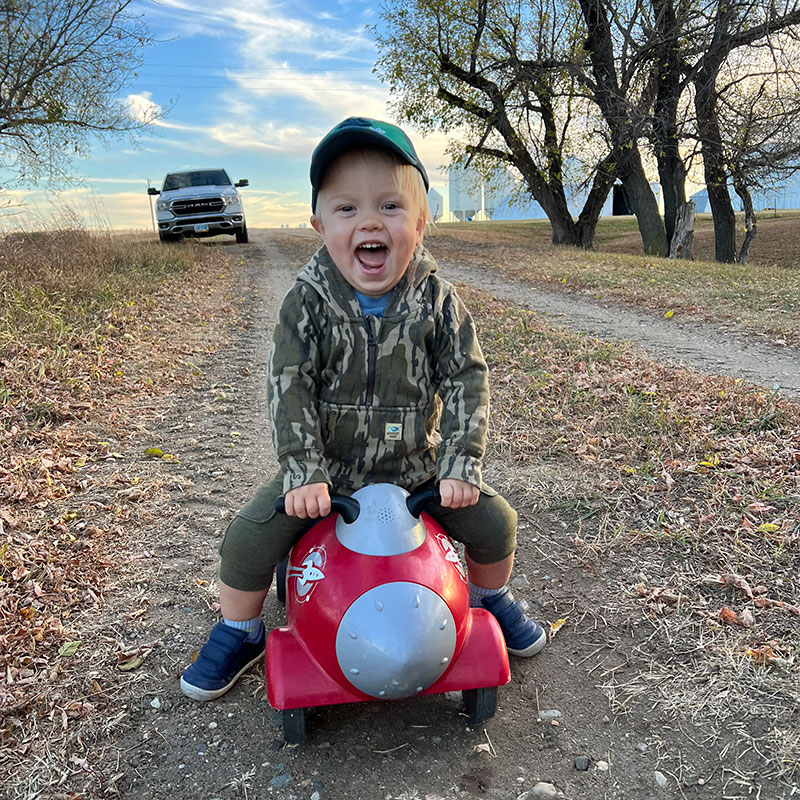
[0,229,234,797]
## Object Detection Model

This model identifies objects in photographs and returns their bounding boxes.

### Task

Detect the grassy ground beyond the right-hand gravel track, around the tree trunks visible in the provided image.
[426,212,800,344]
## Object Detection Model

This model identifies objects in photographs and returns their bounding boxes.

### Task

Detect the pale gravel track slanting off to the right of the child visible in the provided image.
[438,261,800,398]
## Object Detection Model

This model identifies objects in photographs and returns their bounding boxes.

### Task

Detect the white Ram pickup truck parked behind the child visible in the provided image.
[147,169,249,244]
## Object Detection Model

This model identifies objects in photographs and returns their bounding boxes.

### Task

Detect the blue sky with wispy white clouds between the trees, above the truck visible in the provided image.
[12,0,454,230]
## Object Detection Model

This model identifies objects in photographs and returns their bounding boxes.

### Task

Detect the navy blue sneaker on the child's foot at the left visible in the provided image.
[181,622,267,700]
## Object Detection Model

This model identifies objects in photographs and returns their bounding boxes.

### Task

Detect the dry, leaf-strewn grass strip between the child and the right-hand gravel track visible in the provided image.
[462,288,800,780]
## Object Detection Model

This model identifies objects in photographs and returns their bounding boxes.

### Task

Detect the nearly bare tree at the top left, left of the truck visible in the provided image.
[0,0,157,182]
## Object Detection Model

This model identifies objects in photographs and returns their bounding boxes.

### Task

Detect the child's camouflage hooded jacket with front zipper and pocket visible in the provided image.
[269,246,489,491]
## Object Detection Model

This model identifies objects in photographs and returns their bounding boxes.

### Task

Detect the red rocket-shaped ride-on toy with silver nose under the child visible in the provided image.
[266,484,510,744]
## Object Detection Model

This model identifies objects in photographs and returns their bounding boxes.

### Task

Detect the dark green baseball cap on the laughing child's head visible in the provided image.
[311,117,431,211]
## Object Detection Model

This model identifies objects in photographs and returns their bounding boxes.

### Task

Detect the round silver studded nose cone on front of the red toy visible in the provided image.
[336,581,456,698]
